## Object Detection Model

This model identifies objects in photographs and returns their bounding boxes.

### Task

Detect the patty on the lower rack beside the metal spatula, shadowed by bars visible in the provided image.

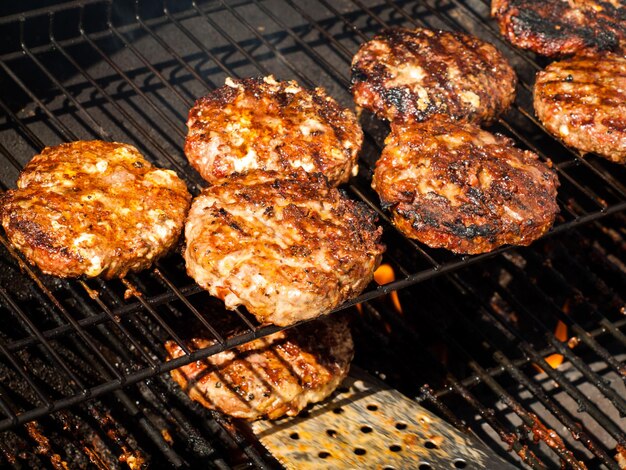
[165,315,354,420]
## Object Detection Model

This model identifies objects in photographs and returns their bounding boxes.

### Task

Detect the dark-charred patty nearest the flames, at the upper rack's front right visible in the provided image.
[372,115,558,254]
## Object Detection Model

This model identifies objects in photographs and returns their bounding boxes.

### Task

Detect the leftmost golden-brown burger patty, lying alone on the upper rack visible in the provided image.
[0,141,191,278]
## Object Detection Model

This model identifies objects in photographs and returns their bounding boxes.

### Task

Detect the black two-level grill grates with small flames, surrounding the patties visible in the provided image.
[0,0,626,469]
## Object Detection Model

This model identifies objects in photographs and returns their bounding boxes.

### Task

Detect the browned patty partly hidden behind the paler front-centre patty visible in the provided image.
[185,76,363,186]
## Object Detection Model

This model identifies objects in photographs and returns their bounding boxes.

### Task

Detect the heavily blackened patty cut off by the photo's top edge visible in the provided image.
[491,0,626,57]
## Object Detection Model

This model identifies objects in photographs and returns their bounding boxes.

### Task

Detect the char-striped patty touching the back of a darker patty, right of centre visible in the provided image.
[352,28,517,122]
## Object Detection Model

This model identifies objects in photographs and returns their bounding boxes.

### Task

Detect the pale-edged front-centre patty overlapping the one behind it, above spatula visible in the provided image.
[185,170,383,326]
